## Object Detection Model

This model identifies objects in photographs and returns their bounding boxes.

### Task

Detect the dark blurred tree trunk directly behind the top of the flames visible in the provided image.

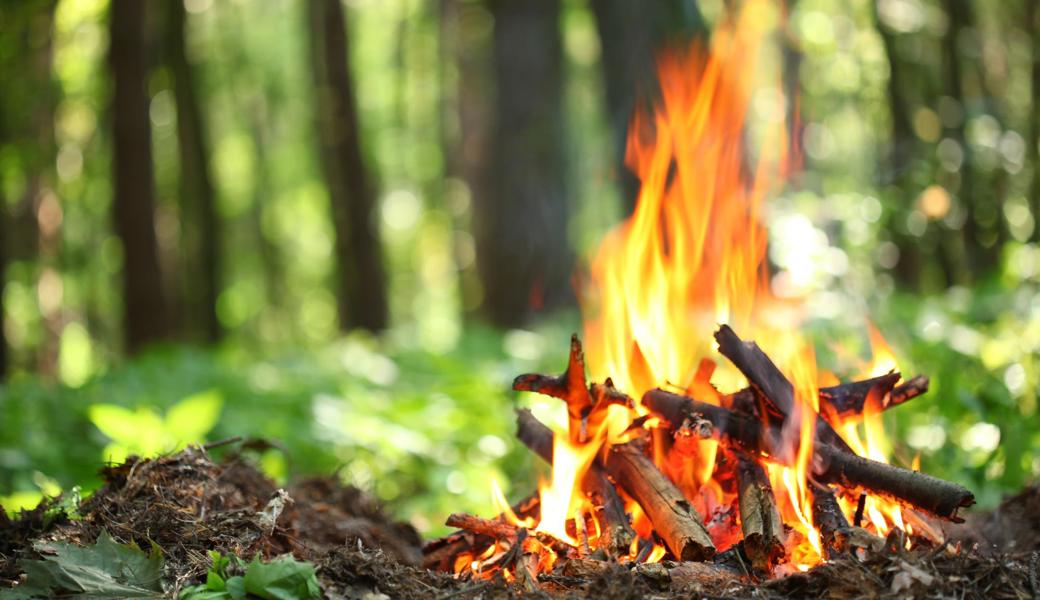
[592,0,708,214]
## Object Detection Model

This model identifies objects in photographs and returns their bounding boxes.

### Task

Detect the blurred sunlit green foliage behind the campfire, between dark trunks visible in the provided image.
[0,0,1040,531]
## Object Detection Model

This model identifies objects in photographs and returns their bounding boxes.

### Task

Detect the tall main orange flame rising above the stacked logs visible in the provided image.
[584,1,786,391]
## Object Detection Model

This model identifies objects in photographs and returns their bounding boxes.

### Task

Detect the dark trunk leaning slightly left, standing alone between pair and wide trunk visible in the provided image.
[308,0,388,332]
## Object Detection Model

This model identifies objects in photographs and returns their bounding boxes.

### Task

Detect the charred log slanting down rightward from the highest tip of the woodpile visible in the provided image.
[714,324,852,455]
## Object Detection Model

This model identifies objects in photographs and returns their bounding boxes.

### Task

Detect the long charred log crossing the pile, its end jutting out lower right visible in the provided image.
[643,389,974,522]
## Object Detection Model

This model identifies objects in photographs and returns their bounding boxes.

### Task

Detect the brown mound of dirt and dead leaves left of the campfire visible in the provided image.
[0,447,420,585]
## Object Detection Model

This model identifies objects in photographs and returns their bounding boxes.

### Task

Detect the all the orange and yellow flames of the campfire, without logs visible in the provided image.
[486,0,919,575]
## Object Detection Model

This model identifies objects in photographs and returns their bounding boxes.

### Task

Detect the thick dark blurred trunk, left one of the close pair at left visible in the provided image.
[108,0,168,353]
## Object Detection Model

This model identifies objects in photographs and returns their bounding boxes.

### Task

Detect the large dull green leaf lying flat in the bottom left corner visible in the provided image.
[12,531,163,598]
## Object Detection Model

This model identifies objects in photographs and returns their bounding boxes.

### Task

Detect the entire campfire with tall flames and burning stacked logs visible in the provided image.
[424,2,974,589]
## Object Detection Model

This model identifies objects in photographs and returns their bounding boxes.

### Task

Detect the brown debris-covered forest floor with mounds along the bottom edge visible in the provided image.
[0,447,1040,600]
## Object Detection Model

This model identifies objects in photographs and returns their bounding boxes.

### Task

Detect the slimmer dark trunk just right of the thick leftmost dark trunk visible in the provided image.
[165,0,224,342]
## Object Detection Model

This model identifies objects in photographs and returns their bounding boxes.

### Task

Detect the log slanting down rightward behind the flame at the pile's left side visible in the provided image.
[517,409,635,556]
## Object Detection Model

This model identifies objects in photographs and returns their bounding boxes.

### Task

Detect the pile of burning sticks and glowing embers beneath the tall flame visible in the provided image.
[424,325,974,588]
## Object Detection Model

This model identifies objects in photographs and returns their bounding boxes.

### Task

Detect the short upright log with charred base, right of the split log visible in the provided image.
[736,454,784,571]
